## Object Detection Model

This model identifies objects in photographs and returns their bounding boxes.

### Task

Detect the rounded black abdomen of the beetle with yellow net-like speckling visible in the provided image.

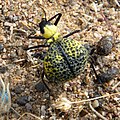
[44,39,89,83]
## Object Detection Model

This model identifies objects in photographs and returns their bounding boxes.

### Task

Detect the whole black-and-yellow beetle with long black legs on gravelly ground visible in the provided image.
[26,8,109,91]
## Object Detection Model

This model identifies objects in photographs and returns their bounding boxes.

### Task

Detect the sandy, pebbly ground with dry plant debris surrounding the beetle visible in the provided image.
[0,0,120,120]
